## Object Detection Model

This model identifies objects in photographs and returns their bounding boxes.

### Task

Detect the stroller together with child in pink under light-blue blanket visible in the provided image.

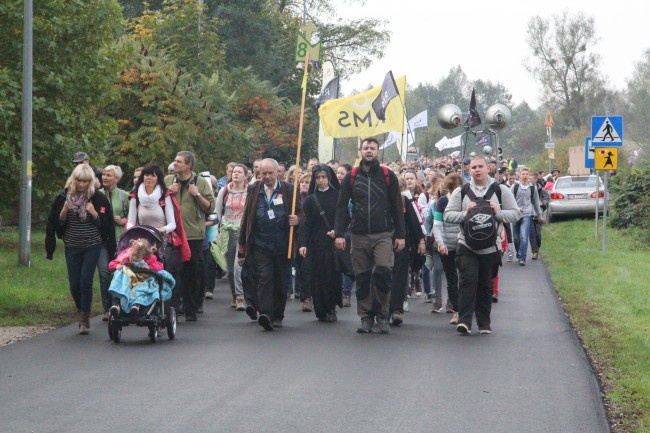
[108,226,176,343]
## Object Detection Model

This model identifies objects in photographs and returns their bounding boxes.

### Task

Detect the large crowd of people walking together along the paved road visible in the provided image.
[45,142,552,335]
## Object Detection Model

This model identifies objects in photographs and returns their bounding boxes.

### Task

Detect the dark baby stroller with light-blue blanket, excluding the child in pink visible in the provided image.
[108,225,176,343]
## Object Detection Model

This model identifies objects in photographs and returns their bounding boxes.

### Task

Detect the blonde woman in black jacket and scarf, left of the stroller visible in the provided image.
[45,164,116,335]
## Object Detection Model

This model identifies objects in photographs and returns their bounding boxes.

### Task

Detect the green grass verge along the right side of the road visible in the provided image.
[541,220,650,433]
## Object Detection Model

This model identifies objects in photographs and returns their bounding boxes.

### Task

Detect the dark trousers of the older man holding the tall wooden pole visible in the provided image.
[246,247,290,320]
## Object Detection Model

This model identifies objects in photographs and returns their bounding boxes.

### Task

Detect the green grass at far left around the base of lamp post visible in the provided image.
[0,229,101,326]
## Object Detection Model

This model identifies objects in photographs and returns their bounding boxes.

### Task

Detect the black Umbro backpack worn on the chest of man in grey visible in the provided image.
[460,183,501,251]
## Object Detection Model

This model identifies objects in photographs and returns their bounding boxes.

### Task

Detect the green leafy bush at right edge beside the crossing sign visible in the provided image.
[610,160,650,239]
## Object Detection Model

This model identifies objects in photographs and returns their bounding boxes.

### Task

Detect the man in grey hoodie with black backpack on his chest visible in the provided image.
[444,156,519,334]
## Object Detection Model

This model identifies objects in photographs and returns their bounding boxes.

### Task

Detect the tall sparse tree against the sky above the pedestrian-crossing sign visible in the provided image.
[526,11,602,129]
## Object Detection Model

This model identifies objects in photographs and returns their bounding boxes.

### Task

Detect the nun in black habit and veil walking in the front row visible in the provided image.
[298,165,342,322]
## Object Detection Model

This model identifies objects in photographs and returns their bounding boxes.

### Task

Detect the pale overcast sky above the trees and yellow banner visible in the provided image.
[336,0,650,107]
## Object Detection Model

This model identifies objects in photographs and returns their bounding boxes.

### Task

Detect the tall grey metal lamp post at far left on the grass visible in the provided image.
[18,0,34,267]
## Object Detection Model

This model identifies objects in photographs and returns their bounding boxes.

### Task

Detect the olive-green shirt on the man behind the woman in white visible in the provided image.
[165,172,214,241]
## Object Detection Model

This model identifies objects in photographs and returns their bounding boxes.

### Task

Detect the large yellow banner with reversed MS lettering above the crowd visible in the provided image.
[318,76,406,138]
